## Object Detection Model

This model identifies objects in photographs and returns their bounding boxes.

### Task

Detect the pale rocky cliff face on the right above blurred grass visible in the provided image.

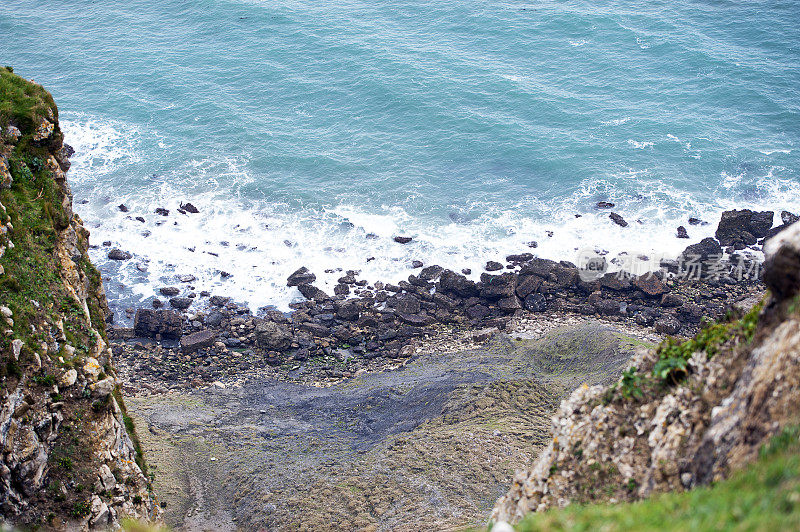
[492,223,800,522]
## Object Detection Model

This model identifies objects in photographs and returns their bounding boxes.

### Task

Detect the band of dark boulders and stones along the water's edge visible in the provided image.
[110,210,797,387]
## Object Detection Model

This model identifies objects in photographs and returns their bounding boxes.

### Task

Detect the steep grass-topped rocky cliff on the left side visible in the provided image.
[0,68,158,530]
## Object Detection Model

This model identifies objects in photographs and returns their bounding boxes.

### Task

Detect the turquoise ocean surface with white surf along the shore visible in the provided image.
[0,0,800,309]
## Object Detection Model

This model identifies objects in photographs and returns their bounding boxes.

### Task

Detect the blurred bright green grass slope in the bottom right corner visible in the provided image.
[516,427,800,532]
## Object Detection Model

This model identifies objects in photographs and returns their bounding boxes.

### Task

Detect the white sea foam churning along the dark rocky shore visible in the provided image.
[64,114,800,318]
